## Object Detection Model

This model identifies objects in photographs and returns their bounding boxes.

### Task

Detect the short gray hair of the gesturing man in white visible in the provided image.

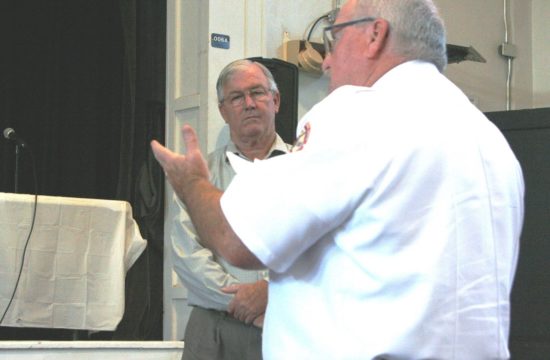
[355,0,447,72]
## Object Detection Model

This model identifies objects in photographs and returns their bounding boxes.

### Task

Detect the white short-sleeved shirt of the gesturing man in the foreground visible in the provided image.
[221,62,524,360]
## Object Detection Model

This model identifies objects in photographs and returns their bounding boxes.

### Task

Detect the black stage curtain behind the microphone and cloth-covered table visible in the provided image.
[0,0,166,340]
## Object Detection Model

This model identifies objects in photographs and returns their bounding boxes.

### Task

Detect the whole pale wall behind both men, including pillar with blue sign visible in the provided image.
[199,0,550,142]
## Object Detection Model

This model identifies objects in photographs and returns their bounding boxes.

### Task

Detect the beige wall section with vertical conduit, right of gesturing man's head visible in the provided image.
[435,0,532,111]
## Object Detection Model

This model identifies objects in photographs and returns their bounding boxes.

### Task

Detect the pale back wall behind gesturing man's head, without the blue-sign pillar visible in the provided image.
[264,0,550,116]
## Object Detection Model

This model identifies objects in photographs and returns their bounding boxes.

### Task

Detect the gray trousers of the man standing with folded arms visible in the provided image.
[182,307,262,360]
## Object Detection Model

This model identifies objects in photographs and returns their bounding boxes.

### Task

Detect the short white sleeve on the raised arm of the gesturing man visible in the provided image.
[221,143,380,272]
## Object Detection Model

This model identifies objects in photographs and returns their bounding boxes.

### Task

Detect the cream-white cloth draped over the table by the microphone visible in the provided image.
[0,193,146,330]
